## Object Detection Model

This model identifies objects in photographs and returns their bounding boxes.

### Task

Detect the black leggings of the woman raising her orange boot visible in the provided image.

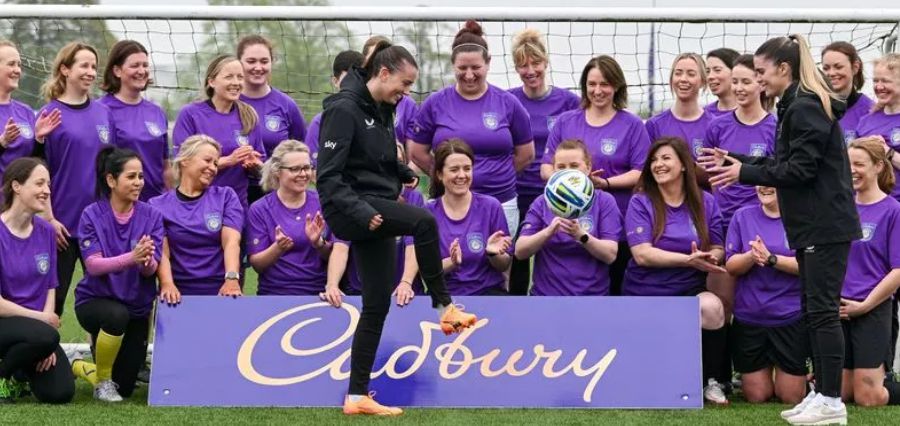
[326,198,451,395]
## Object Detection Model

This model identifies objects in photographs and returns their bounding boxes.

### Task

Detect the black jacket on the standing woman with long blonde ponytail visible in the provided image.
[732,83,862,250]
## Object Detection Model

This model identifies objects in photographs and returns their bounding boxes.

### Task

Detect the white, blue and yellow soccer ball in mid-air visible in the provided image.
[544,169,594,219]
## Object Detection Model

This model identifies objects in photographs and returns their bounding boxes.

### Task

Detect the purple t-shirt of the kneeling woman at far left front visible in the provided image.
[0,216,59,311]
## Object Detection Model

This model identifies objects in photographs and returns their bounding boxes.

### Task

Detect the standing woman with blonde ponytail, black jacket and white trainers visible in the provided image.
[700,34,862,425]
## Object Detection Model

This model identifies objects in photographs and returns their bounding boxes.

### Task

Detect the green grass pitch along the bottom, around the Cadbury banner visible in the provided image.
[0,270,900,426]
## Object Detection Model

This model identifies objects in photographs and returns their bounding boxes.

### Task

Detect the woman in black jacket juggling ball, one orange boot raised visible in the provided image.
[318,41,476,416]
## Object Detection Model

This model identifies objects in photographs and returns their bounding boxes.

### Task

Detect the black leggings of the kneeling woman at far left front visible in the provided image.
[0,317,75,404]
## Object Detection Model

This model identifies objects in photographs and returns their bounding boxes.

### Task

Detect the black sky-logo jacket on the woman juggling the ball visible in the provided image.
[316,68,416,227]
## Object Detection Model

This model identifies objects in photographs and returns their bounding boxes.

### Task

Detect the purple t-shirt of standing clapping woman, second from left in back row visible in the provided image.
[41,100,116,238]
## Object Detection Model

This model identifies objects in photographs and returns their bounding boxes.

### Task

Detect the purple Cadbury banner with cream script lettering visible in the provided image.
[149,297,703,408]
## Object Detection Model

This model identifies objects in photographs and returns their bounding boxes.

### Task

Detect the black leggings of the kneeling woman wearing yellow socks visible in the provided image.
[75,299,150,398]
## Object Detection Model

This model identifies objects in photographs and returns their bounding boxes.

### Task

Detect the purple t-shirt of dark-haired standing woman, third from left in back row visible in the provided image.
[97,95,169,201]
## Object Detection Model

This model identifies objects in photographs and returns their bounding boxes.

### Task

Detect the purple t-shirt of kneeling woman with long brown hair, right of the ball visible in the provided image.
[622,192,724,296]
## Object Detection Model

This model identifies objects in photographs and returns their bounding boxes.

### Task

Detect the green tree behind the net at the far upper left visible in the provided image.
[0,0,116,109]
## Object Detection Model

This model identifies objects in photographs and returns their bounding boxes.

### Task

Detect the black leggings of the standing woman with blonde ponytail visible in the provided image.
[797,243,850,398]
